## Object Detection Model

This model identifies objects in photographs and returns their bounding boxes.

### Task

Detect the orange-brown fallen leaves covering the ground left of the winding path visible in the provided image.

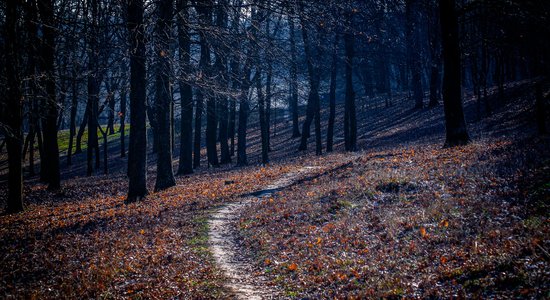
[0,165,298,299]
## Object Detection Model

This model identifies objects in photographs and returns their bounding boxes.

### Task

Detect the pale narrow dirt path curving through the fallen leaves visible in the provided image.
[208,166,319,299]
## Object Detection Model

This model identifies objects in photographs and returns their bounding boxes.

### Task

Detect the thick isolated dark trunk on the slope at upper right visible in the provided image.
[439,0,469,147]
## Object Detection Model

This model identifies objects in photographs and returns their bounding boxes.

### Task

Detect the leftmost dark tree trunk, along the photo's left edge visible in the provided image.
[3,0,23,213]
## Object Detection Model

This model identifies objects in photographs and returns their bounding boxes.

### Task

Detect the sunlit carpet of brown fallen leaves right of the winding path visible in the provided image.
[239,136,550,298]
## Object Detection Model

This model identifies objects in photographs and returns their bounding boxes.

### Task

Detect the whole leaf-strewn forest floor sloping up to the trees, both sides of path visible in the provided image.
[0,82,550,299]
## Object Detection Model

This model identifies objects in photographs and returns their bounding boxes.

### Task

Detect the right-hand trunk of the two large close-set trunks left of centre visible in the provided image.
[155,0,176,191]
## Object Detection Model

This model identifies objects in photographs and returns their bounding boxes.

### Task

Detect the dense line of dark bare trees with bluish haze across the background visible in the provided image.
[0,0,550,212]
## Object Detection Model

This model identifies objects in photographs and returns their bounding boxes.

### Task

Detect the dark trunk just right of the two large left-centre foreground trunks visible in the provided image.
[176,0,193,175]
